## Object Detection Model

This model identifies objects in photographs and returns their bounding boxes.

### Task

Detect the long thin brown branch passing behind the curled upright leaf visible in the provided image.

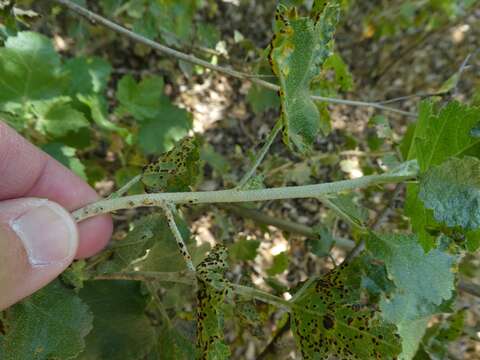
[55,0,417,117]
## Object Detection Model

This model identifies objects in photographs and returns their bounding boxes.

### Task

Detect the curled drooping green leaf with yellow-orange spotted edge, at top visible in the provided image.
[269,1,340,153]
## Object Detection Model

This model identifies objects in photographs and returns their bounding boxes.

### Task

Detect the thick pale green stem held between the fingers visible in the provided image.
[72,171,417,222]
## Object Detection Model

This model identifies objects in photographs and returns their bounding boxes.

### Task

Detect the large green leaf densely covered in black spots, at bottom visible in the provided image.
[291,262,401,360]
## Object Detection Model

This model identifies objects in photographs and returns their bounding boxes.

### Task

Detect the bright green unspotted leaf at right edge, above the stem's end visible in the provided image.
[408,101,480,172]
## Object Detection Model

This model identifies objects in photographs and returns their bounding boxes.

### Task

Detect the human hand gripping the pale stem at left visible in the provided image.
[0,120,112,310]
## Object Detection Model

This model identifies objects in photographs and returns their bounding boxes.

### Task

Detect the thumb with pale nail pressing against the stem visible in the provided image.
[0,198,78,310]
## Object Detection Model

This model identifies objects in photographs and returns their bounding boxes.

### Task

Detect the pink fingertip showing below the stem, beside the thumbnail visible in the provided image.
[75,215,113,259]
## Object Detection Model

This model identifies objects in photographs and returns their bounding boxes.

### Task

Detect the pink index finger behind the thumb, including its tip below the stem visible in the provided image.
[0,121,112,258]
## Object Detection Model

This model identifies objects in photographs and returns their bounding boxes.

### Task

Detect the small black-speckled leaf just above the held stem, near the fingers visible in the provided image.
[141,137,201,192]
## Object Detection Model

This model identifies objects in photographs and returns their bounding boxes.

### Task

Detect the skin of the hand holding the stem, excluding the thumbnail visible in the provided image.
[0,120,112,310]
